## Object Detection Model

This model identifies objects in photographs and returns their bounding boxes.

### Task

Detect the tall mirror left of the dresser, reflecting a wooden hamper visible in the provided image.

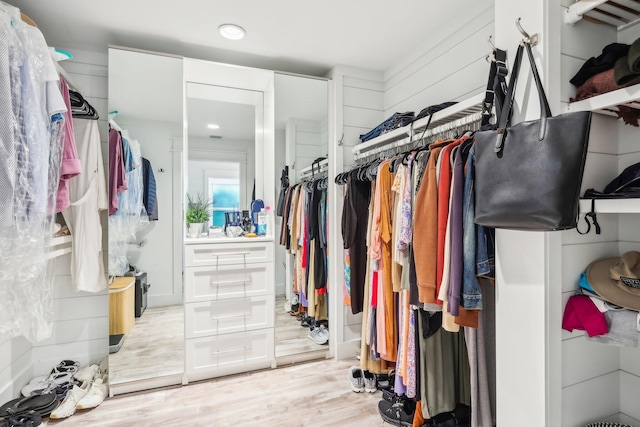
[109,49,184,394]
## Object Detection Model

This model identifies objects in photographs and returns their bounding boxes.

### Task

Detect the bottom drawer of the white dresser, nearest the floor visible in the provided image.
[186,328,274,381]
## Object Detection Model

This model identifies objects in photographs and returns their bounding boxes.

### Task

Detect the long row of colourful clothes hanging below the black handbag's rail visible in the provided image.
[336,128,495,426]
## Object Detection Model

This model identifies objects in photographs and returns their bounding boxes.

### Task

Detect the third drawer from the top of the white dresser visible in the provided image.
[185,295,274,338]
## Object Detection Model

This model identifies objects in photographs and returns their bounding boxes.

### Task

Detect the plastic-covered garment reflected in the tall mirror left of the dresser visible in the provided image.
[109,131,149,276]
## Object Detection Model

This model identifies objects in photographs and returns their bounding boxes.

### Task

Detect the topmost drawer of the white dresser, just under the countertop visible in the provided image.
[184,242,273,267]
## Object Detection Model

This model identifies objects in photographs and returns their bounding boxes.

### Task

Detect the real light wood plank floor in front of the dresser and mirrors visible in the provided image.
[45,359,388,427]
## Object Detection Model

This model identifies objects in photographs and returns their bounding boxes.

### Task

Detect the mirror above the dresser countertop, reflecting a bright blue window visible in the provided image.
[187,83,262,237]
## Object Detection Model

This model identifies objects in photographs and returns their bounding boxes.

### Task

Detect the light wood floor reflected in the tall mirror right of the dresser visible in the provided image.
[275,295,329,357]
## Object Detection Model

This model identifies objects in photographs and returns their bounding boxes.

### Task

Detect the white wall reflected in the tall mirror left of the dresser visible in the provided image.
[116,117,182,307]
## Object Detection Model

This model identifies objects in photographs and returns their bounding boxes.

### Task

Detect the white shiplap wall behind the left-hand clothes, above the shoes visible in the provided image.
[0,47,109,402]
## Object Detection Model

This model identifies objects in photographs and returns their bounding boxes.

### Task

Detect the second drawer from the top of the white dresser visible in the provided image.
[184,263,274,303]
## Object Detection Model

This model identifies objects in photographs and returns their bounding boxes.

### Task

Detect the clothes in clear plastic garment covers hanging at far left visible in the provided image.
[0,14,66,342]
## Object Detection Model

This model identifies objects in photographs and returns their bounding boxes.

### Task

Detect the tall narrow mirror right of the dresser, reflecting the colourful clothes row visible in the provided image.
[275,74,329,364]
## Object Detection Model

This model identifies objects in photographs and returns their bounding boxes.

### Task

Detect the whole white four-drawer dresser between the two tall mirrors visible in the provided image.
[184,237,275,382]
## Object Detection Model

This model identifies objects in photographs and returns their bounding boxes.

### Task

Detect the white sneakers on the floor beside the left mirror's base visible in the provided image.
[50,365,108,419]
